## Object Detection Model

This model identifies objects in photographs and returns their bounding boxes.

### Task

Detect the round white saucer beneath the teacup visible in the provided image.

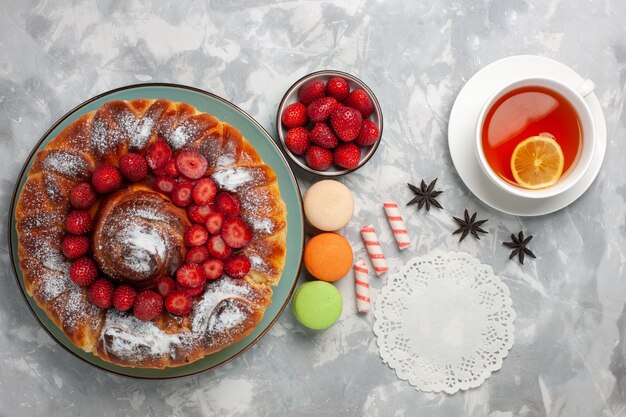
[448,55,606,216]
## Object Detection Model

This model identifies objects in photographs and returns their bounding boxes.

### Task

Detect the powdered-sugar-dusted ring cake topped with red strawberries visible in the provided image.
[16,99,287,368]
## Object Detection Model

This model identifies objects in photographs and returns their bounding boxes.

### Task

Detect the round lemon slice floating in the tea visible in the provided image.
[511,134,565,190]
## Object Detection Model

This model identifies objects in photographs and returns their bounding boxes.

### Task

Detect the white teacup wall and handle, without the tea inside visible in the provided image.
[475,78,597,198]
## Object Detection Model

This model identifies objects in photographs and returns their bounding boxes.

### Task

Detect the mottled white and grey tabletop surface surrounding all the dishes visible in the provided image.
[0,0,626,417]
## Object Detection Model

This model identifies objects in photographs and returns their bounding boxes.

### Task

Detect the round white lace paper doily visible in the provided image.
[374,252,515,394]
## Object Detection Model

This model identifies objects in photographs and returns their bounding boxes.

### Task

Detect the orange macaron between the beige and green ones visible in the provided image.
[304,233,352,282]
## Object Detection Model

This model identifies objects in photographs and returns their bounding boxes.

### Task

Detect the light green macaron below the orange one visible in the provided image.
[291,281,343,330]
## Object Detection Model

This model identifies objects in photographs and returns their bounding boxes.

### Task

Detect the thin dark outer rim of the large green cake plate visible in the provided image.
[7,82,306,380]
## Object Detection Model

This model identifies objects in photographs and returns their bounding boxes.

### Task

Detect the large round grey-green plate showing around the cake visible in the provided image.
[8,83,304,379]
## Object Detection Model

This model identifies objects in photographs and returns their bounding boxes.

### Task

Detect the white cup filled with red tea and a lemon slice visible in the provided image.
[475,77,597,199]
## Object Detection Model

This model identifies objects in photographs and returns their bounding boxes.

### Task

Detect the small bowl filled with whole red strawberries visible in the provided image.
[276,70,383,177]
